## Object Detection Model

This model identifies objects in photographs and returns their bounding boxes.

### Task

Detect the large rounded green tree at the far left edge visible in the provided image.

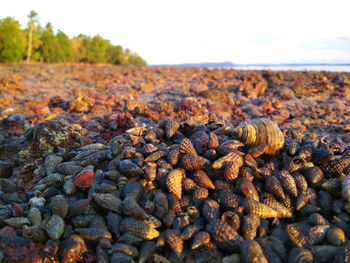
[0,17,25,62]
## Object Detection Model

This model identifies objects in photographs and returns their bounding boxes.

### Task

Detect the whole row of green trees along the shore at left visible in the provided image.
[0,11,146,65]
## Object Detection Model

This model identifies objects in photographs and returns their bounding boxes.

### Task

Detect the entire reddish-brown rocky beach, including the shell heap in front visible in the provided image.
[0,63,350,263]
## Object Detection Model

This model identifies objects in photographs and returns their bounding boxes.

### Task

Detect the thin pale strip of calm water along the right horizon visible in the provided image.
[227,64,350,72]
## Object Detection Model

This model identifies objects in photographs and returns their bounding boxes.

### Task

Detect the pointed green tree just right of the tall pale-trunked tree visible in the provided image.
[40,23,63,62]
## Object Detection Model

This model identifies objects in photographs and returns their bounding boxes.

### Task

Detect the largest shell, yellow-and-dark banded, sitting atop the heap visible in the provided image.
[234,118,284,155]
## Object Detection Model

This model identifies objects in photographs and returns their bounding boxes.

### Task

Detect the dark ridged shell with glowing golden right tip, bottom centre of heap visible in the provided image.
[120,217,159,240]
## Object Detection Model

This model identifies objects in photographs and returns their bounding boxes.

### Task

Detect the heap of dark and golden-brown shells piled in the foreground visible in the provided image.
[0,118,350,263]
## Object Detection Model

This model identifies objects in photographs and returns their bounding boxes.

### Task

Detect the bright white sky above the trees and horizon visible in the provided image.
[0,0,350,64]
